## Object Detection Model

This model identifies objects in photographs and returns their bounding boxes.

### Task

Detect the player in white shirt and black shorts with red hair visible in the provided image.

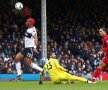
[15,18,43,80]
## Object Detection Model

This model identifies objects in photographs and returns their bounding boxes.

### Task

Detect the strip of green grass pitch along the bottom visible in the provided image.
[0,81,108,90]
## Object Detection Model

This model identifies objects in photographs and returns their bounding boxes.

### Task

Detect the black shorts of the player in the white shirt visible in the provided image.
[20,47,33,58]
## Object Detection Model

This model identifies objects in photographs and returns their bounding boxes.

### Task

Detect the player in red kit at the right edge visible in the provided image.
[92,27,108,83]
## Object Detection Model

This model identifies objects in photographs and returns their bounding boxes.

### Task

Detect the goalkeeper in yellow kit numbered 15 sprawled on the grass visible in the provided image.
[41,52,92,84]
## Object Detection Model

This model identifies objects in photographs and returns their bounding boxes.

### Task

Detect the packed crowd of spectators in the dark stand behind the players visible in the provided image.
[0,0,108,74]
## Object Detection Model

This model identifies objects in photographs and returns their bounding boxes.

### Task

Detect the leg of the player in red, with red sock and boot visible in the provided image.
[92,57,108,83]
